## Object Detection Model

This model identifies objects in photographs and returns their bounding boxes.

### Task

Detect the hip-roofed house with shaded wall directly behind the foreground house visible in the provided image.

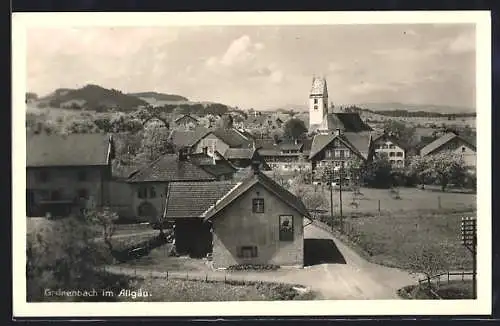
[126,150,217,222]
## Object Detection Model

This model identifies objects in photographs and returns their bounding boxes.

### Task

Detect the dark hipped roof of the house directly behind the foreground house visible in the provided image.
[127,154,215,182]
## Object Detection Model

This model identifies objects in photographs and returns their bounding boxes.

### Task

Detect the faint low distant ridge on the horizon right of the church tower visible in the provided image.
[356,102,476,114]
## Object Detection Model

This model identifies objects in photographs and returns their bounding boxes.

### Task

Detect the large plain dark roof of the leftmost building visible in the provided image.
[26,134,113,167]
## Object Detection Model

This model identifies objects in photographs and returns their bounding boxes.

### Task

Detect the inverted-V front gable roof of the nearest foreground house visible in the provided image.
[202,173,309,221]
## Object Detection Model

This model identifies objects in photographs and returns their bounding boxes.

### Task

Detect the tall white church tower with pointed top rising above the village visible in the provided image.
[309,77,328,131]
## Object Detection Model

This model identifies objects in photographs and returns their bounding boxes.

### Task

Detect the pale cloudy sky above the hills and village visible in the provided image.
[27,24,476,109]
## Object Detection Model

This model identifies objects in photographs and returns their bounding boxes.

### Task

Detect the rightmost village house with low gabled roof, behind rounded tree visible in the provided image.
[420,132,476,168]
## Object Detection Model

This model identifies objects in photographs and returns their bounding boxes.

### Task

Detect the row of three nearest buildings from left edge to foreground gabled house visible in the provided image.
[26,134,309,268]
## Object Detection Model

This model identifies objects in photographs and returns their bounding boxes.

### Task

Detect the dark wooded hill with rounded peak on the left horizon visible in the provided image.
[39,84,148,112]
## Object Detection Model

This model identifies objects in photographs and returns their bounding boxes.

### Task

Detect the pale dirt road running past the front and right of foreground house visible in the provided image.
[106,224,416,300]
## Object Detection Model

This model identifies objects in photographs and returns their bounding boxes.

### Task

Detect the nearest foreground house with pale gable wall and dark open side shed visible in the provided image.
[163,167,309,268]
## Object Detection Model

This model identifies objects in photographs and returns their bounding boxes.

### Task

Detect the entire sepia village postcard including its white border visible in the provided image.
[12,12,491,316]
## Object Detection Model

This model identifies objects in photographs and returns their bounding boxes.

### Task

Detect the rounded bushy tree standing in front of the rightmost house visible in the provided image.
[426,152,467,191]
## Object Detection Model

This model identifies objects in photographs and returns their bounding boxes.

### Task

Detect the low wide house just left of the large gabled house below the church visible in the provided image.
[256,139,311,172]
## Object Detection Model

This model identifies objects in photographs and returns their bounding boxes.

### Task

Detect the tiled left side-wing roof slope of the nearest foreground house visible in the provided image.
[163,181,236,219]
